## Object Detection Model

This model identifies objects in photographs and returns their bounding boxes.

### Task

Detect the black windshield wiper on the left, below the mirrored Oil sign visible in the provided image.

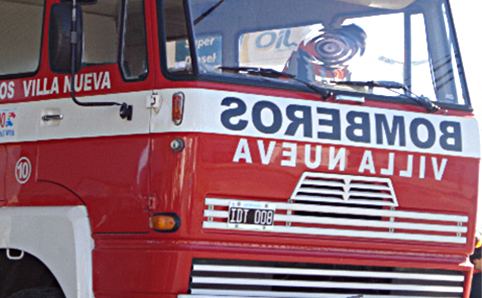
[219,66,333,100]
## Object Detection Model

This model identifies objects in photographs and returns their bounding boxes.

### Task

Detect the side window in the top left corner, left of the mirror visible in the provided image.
[0,0,44,76]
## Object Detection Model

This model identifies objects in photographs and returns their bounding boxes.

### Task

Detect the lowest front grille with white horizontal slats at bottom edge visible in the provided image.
[180,259,464,298]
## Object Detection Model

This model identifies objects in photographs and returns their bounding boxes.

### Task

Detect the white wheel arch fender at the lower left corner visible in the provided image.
[0,206,94,298]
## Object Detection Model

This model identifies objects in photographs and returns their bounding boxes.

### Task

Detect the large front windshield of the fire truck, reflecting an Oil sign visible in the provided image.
[164,0,468,105]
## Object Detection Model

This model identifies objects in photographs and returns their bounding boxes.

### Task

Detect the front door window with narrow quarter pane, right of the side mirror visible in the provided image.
[82,0,147,80]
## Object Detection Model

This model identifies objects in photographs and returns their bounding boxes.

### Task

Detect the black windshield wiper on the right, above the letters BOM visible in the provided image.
[330,81,440,113]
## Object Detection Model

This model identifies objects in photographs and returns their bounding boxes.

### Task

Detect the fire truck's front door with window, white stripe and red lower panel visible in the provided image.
[38,0,152,233]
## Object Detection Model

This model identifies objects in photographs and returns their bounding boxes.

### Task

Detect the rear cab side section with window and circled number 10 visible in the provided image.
[0,0,45,205]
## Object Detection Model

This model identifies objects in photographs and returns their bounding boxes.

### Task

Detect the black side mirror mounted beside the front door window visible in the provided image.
[49,2,84,74]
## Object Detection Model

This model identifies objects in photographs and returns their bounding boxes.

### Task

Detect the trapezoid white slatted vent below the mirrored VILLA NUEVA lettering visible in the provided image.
[291,173,398,207]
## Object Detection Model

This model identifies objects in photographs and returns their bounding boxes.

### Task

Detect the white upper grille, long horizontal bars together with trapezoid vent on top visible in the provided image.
[203,173,468,245]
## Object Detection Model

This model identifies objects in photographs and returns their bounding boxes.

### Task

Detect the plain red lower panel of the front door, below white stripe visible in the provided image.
[38,135,149,233]
